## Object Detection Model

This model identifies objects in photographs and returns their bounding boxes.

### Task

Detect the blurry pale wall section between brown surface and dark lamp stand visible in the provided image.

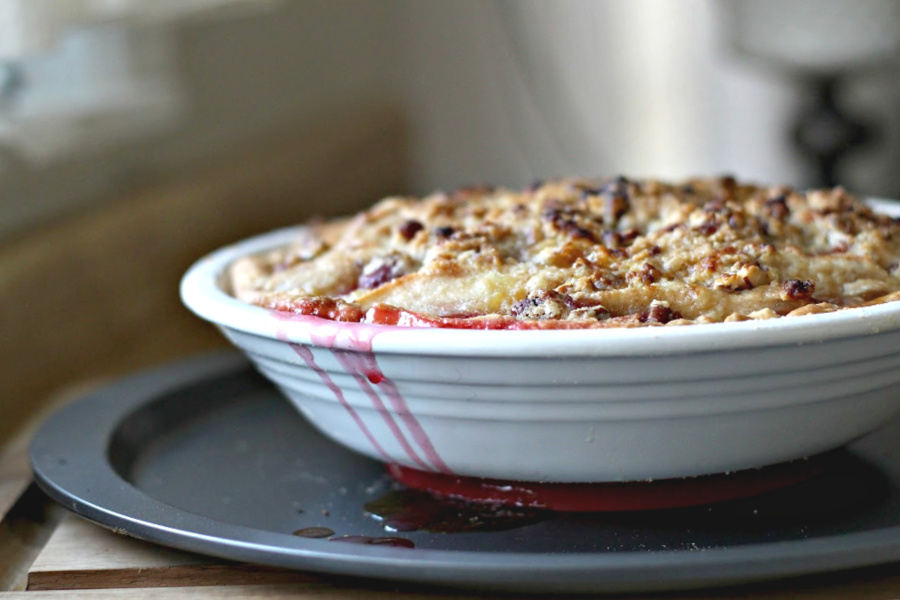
[394,0,816,188]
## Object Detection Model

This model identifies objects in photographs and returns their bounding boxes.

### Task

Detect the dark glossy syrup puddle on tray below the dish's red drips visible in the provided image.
[364,489,552,533]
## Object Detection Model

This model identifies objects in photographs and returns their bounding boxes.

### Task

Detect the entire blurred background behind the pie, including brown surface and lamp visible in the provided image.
[0,0,900,433]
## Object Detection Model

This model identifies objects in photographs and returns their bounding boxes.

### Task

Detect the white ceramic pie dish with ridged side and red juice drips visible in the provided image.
[181,204,900,482]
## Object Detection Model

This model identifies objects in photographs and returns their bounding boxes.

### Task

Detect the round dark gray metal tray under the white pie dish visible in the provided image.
[31,354,900,592]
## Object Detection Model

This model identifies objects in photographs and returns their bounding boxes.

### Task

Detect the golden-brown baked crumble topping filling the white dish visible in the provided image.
[231,177,900,328]
